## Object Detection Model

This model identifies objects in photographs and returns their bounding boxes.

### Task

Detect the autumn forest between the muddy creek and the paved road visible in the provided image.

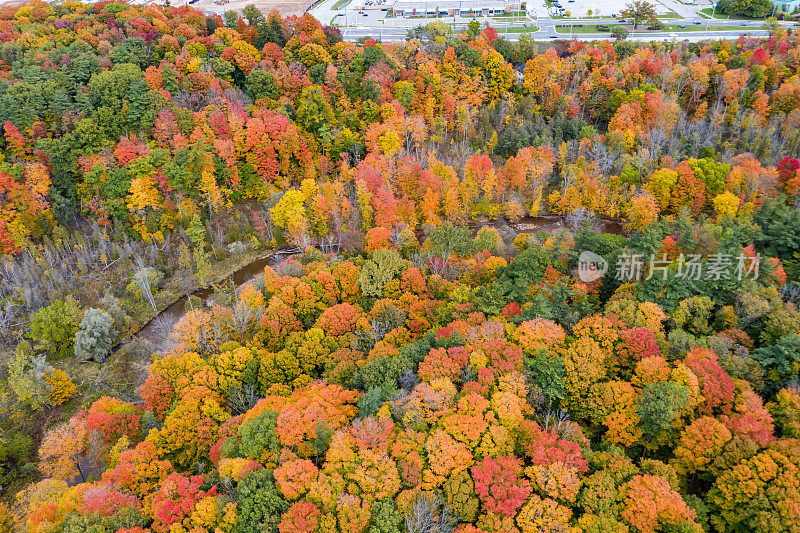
[0,2,800,253]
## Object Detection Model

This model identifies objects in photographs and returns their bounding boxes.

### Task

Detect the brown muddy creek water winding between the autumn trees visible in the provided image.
[135,216,623,346]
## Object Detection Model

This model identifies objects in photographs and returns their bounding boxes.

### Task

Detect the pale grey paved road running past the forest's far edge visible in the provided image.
[308,0,788,42]
